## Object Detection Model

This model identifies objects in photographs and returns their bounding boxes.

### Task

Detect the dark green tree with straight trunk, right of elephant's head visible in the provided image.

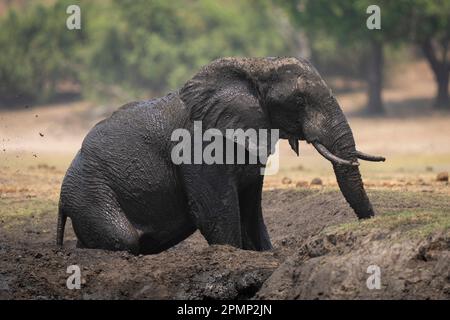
[284,0,410,114]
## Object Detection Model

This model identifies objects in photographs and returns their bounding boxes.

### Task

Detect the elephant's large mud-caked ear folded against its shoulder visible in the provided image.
[180,60,267,130]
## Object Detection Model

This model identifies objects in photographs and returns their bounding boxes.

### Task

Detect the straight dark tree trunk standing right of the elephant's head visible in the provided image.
[366,40,384,114]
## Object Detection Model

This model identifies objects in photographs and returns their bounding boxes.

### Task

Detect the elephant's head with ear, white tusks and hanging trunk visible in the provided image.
[181,58,385,218]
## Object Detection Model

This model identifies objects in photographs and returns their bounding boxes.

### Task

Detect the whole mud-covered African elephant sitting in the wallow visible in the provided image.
[57,58,384,254]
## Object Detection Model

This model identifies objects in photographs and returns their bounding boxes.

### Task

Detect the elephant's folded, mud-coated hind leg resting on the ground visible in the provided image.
[70,192,139,254]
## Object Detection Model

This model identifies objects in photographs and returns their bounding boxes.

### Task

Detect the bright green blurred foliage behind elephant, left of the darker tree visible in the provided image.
[0,0,292,101]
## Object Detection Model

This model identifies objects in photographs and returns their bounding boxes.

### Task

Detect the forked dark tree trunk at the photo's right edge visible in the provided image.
[422,39,450,109]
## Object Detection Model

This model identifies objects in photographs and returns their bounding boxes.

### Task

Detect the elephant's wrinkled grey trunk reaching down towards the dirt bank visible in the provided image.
[316,109,374,219]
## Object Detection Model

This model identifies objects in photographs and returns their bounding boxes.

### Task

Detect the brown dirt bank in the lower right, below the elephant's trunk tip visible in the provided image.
[256,221,450,299]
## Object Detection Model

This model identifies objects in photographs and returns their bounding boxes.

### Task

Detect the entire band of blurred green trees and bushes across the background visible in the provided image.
[0,0,450,114]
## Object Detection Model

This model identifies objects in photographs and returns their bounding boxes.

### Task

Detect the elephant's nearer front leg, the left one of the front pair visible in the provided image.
[180,165,243,248]
